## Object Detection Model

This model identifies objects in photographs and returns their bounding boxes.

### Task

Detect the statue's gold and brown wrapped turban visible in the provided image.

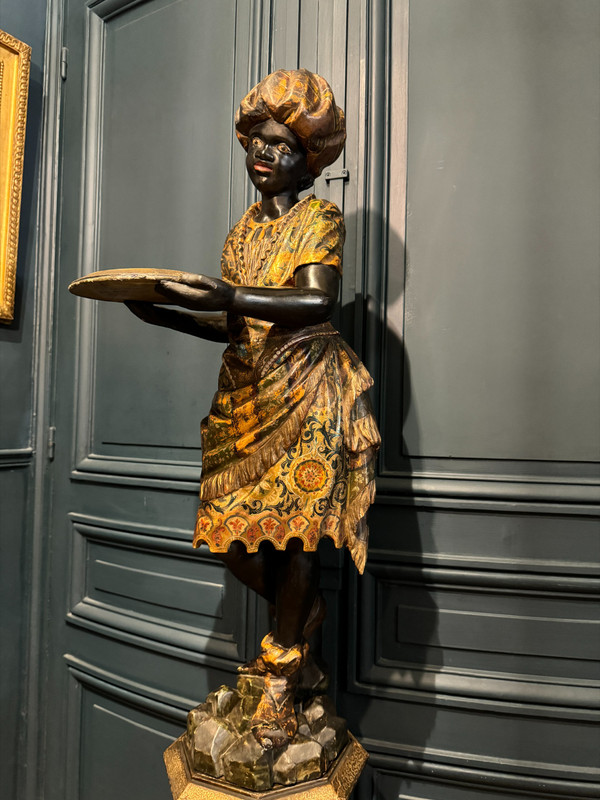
[235,69,346,189]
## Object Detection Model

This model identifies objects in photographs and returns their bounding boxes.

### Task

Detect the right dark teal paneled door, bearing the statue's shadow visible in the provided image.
[344,0,600,800]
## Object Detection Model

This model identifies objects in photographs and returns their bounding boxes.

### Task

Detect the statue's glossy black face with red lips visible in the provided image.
[246,119,308,196]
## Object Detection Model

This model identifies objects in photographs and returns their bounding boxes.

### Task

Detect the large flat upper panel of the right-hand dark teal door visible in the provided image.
[404,0,600,462]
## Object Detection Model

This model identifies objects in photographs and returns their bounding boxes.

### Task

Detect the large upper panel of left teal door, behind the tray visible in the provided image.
[77,2,237,480]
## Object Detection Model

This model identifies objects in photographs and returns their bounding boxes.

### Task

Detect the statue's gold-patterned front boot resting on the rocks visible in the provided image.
[250,633,308,749]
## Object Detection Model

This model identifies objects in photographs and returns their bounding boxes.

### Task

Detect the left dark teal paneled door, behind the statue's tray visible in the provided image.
[44,0,262,800]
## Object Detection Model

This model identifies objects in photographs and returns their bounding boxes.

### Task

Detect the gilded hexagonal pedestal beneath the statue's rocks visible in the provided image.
[164,734,368,800]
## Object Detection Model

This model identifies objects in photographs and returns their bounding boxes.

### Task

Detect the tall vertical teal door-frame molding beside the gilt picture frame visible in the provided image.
[19,0,64,798]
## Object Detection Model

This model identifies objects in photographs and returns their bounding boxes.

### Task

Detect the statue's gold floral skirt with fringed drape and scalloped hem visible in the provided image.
[194,325,380,572]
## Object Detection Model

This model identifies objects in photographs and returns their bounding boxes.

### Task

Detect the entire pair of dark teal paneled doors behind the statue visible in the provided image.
[43,0,600,800]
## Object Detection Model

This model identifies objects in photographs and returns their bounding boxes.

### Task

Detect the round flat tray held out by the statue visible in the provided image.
[69,269,189,304]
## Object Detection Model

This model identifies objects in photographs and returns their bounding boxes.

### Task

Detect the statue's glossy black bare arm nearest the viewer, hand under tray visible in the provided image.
[157,264,340,328]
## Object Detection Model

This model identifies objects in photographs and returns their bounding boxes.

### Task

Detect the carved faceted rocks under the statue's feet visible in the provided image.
[185,675,348,792]
